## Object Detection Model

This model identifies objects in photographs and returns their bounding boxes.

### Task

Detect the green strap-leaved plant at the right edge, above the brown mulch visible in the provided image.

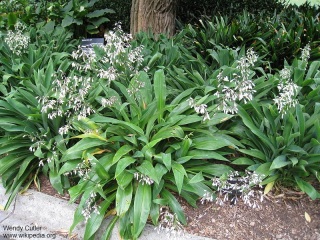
[233,55,320,199]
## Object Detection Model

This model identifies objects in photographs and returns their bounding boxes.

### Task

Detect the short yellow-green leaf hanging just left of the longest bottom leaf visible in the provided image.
[116,184,133,217]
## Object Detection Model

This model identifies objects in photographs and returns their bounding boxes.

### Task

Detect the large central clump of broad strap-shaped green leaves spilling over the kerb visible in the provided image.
[60,70,237,239]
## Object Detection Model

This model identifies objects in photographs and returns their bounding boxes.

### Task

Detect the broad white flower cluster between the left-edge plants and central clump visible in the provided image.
[38,73,94,135]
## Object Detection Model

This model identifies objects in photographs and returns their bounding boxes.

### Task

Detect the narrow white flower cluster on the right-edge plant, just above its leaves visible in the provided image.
[273,68,299,117]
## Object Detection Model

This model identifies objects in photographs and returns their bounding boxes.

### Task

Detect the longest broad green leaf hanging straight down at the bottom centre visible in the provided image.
[132,184,151,239]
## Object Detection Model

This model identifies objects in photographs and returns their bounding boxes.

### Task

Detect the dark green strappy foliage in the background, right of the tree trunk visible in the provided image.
[182,6,320,70]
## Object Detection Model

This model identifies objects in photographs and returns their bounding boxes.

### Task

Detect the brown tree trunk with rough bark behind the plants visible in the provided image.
[130,0,177,36]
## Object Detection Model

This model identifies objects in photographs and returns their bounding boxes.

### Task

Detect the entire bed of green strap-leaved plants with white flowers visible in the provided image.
[0,0,320,239]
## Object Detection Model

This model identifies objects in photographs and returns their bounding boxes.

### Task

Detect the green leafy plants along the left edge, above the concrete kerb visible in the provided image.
[0,23,78,208]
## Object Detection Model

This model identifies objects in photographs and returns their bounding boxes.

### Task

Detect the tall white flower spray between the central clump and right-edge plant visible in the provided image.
[215,48,258,114]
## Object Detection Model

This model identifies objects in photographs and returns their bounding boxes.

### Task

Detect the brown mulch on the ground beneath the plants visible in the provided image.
[31,176,320,240]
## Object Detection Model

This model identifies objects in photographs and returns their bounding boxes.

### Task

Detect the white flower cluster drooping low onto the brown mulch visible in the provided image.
[212,171,264,208]
